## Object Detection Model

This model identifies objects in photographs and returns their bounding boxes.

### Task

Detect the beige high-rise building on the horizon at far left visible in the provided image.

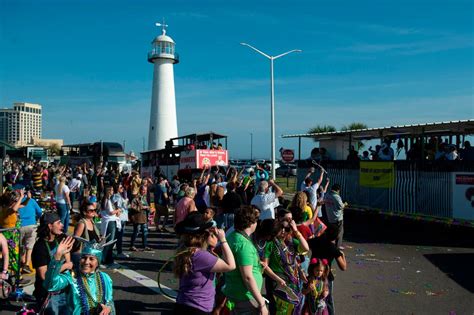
[0,103,42,146]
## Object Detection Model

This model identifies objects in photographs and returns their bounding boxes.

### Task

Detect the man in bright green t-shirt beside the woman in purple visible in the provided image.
[222,206,268,315]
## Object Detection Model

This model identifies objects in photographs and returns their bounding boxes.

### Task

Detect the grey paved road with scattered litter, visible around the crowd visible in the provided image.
[2,213,474,315]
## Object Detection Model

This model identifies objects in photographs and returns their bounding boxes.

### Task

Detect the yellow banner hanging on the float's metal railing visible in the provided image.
[359,161,395,188]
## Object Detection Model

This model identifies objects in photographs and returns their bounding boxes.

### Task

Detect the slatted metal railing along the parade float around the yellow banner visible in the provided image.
[297,161,474,218]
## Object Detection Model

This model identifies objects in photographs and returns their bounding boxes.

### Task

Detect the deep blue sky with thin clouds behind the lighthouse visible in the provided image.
[0,0,474,158]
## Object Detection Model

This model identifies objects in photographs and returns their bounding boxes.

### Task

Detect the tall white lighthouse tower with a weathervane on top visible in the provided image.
[148,22,179,150]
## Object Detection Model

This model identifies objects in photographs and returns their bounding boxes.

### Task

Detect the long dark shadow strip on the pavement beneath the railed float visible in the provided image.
[344,209,474,248]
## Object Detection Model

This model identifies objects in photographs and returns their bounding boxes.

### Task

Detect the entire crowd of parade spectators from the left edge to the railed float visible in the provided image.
[0,161,347,315]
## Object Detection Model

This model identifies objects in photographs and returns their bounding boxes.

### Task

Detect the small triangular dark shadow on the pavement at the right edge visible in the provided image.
[424,253,474,293]
